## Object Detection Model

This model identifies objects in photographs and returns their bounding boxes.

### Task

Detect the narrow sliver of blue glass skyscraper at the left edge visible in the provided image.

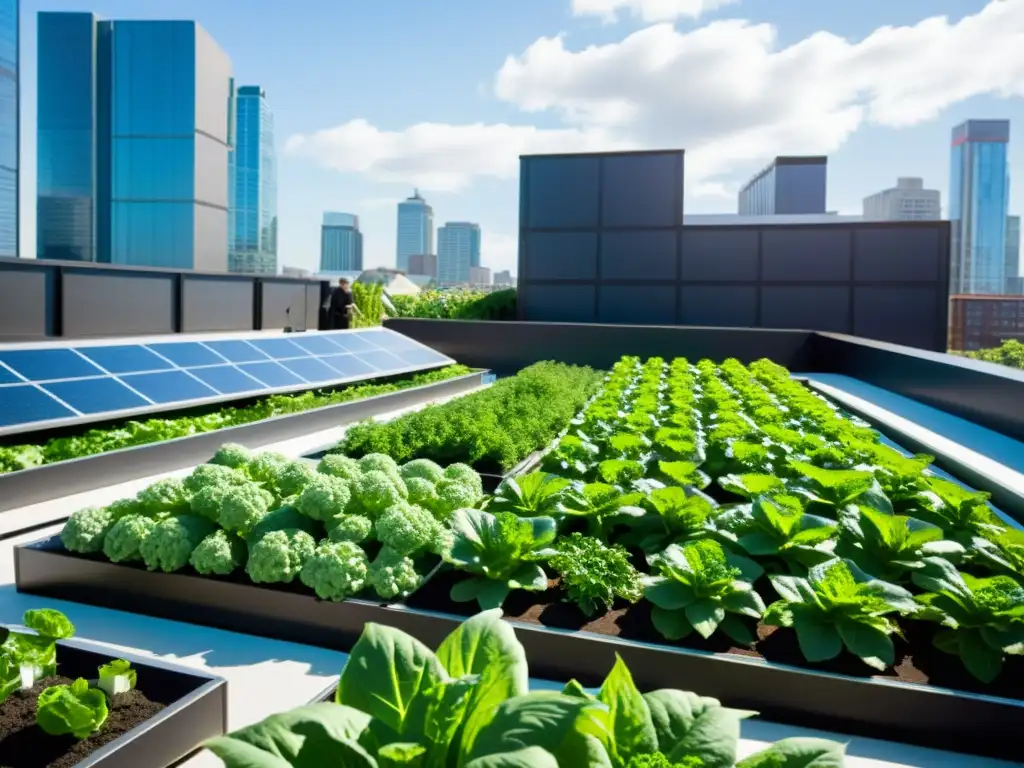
[0,0,19,257]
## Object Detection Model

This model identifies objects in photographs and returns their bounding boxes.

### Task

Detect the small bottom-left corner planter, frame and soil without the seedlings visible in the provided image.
[0,638,227,768]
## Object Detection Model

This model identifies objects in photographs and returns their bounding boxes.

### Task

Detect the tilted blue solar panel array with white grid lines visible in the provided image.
[0,329,455,435]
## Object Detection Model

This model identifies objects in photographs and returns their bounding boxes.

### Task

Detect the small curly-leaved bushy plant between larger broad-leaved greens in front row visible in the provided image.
[548,534,643,615]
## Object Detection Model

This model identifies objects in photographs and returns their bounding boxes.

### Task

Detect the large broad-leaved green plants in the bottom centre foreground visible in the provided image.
[207,611,845,768]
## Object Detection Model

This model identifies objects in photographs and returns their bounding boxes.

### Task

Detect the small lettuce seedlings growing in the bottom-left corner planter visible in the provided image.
[0,608,146,739]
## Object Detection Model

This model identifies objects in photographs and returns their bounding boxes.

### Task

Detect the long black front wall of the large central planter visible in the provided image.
[14,537,1024,760]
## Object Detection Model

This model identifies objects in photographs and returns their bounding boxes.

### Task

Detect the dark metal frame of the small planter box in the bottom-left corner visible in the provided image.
[6,638,227,768]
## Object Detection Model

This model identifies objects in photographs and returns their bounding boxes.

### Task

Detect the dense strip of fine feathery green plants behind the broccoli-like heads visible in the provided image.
[336,362,601,470]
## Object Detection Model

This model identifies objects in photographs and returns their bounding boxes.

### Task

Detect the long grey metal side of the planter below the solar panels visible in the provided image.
[0,372,485,512]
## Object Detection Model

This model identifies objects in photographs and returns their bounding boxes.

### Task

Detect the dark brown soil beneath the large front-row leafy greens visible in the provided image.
[408,571,1024,699]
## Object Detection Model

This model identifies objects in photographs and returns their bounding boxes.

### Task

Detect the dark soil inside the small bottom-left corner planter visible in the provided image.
[0,677,165,768]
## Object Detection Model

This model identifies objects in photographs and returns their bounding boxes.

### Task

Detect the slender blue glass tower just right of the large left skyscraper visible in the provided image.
[227,85,278,274]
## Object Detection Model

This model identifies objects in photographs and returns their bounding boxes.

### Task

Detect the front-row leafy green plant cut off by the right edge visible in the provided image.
[912,558,1024,683]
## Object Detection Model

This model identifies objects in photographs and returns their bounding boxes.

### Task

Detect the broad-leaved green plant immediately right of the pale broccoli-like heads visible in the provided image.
[446,509,557,610]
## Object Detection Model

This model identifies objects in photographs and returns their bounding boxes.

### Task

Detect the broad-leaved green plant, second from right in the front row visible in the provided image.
[762,558,921,670]
